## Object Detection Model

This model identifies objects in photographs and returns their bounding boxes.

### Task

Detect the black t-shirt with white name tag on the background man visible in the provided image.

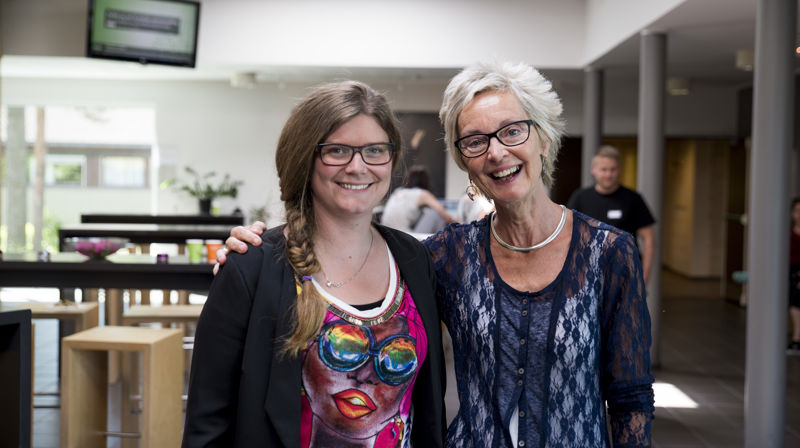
[567,185,656,236]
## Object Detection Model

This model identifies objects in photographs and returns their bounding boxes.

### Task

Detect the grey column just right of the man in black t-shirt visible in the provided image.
[636,32,667,366]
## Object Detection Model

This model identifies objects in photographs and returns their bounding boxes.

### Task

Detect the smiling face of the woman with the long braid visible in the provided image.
[311,115,392,220]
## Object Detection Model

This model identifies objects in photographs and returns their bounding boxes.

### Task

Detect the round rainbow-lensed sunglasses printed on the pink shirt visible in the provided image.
[317,320,418,386]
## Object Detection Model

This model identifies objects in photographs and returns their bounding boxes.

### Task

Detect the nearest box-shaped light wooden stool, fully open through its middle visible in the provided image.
[61,326,183,448]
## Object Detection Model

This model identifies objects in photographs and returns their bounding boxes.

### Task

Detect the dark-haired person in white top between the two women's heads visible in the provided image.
[381,165,456,233]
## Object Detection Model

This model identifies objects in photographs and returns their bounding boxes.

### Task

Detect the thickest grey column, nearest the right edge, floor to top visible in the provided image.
[744,0,797,448]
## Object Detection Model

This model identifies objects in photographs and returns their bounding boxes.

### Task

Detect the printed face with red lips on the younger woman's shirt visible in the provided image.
[303,316,416,439]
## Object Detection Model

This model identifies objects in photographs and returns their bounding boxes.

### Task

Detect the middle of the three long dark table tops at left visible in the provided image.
[58,224,232,251]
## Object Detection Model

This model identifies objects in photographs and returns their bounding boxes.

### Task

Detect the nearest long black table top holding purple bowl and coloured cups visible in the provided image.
[0,252,214,291]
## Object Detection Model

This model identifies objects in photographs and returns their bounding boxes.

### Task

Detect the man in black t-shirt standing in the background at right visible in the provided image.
[567,146,656,284]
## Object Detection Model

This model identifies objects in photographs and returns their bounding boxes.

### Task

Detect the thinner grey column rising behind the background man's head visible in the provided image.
[581,67,603,188]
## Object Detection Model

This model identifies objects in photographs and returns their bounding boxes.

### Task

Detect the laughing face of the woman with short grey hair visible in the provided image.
[458,91,547,210]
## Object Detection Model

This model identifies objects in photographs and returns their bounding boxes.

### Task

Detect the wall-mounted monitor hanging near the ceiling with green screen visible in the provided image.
[86,0,200,67]
